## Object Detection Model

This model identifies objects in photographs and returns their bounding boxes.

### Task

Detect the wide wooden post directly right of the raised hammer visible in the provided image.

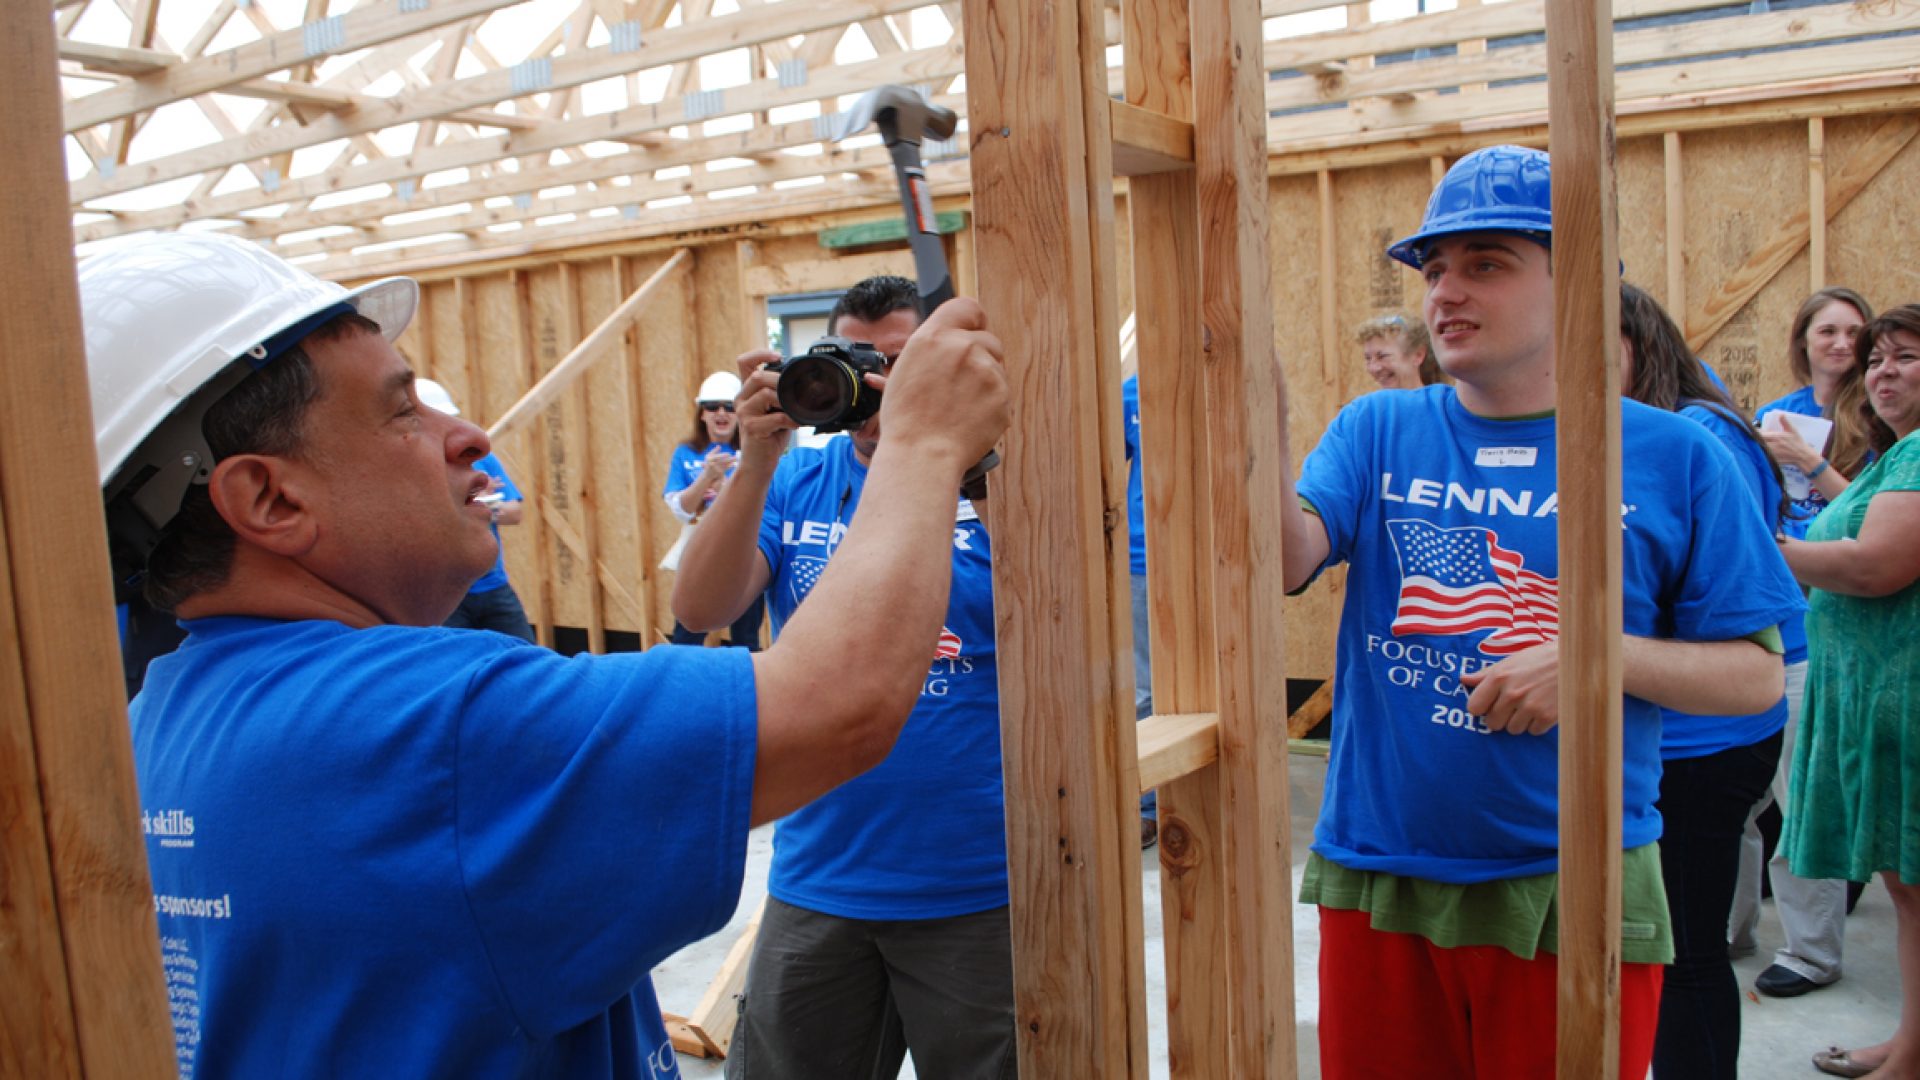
[964,0,1144,1080]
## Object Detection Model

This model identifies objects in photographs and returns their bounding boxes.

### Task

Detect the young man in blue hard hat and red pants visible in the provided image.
[1283,146,1801,1078]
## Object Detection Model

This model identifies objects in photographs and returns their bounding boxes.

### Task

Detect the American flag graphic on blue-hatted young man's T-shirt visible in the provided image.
[1386,519,1559,655]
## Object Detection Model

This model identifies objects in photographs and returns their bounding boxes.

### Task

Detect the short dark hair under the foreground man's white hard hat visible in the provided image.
[140,313,380,611]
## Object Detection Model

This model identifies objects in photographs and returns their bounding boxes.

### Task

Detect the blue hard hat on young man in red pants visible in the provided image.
[1386,146,1553,269]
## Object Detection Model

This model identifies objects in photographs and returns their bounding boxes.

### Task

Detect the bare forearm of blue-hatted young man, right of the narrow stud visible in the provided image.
[1620,636,1786,717]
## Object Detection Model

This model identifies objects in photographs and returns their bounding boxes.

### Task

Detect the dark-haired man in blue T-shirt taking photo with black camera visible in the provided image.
[674,277,1016,1080]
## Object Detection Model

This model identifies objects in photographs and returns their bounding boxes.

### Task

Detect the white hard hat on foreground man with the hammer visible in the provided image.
[79,233,420,588]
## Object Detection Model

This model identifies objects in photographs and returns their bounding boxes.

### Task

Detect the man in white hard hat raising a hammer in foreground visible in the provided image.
[81,234,1006,1078]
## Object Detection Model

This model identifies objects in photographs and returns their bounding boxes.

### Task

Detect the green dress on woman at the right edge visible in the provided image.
[1782,432,1920,884]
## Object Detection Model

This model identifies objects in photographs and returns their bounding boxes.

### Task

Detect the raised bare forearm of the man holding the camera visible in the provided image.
[674,457,774,630]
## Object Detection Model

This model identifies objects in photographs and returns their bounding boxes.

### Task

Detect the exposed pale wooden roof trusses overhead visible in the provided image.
[56,0,1920,275]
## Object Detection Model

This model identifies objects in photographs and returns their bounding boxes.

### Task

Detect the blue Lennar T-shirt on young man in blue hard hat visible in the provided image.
[1300,386,1803,884]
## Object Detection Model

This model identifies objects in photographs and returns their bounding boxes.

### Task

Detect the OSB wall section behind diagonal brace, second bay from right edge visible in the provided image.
[1681,123,1809,411]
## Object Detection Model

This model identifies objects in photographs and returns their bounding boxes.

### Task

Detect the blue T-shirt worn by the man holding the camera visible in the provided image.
[760,436,1008,919]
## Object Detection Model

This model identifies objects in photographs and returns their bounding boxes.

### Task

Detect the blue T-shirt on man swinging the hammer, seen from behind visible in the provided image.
[131,617,756,1080]
